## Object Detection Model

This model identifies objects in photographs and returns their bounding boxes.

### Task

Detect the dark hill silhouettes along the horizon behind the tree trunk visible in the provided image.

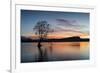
[21,36,89,42]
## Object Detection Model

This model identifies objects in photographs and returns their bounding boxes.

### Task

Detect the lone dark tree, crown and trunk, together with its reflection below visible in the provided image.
[33,21,53,61]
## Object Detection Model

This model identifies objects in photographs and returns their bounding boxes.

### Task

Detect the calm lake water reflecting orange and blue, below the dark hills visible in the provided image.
[21,42,89,63]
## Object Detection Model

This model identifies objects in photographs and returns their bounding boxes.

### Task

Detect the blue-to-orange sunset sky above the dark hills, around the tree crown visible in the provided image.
[21,10,89,38]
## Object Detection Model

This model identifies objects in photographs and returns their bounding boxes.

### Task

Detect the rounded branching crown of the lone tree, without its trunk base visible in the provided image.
[33,21,51,40]
